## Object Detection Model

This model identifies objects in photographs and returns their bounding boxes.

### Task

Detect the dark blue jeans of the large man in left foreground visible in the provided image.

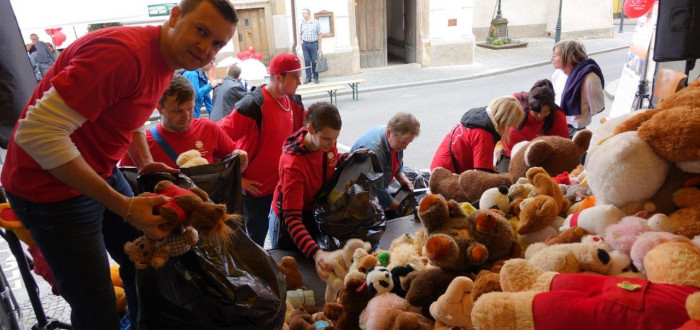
[7,168,141,330]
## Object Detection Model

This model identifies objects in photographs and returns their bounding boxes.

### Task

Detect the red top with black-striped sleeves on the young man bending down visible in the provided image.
[272,129,338,258]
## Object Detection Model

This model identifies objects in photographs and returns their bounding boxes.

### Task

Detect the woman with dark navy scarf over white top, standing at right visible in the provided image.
[552,40,605,137]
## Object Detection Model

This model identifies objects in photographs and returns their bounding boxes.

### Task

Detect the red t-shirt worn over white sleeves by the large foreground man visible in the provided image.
[2,26,173,203]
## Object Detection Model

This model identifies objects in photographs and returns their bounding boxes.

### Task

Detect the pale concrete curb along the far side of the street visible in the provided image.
[304,45,629,100]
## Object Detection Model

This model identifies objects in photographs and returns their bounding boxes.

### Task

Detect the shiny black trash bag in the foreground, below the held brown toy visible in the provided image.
[136,220,287,330]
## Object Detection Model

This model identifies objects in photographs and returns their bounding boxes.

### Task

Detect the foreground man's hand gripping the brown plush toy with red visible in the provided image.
[122,196,170,240]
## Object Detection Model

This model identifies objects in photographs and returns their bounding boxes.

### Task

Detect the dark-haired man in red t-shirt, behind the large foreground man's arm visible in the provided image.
[121,74,247,168]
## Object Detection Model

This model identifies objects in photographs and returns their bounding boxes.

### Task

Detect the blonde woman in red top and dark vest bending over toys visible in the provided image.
[430,96,524,173]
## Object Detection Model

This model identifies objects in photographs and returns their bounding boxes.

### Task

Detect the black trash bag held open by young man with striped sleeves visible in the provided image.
[309,150,386,251]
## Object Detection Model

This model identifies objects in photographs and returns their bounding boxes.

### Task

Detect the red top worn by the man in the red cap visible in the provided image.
[217,87,304,196]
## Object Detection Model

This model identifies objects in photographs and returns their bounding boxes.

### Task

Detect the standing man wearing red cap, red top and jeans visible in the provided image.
[216,54,304,246]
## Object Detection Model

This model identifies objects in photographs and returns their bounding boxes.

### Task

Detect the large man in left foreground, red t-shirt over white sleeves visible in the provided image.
[0,0,238,329]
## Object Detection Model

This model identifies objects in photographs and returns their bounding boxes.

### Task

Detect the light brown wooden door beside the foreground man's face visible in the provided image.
[236,8,270,65]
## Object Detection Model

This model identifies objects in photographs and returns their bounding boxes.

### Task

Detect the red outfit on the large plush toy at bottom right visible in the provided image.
[532,274,700,330]
